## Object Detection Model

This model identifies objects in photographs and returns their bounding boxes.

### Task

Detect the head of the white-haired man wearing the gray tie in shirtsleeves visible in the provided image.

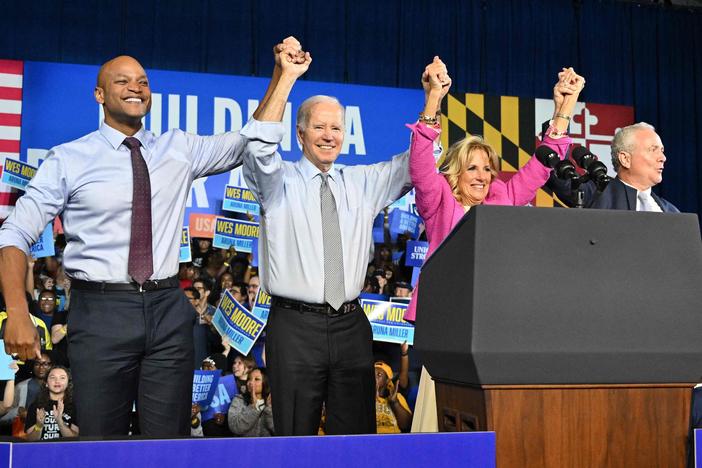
[297,101,344,172]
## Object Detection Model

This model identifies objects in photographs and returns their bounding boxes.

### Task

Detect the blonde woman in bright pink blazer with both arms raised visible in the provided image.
[405,57,585,321]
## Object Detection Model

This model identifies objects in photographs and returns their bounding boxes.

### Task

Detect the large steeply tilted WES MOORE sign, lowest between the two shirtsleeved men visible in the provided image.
[212,291,266,356]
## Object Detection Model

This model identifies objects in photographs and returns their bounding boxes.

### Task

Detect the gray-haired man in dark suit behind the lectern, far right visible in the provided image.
[548,122,679,213]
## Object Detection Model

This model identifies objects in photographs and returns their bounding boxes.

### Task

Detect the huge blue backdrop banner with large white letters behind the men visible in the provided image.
[20,59,424,226]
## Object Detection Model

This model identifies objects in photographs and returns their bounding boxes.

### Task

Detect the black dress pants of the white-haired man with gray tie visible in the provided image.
[266,305,376,435]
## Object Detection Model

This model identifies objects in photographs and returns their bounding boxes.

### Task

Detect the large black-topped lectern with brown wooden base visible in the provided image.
[415,206,702,467]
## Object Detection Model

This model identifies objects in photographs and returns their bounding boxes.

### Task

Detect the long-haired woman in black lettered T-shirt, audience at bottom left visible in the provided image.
[24,366,79,440]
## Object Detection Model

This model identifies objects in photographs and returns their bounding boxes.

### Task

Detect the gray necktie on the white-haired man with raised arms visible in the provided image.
[319,173,346,310]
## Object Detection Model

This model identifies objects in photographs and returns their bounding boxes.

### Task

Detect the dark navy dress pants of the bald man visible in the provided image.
[68,288,195,437]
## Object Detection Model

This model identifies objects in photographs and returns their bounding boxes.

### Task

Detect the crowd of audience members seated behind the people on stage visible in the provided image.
[0,230,418,441]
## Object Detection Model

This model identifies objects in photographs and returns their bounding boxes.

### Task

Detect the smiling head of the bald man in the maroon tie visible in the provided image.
[95,56,151,135]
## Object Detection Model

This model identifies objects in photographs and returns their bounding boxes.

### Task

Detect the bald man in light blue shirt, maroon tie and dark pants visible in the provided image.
[0,56,256,437]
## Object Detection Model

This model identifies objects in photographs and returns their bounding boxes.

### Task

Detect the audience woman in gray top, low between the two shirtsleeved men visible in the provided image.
[227,368,274,437]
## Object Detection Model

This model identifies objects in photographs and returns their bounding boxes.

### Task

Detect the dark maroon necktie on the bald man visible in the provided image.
[124,137,154,284]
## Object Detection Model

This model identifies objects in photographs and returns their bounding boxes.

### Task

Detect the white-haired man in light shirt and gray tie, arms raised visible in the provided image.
[242,40,418,435]
